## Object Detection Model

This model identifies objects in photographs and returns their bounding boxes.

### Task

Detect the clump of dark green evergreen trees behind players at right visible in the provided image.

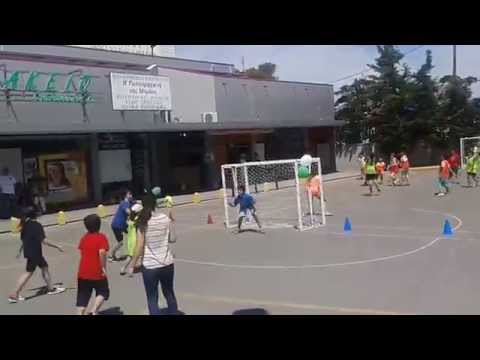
[335,45,480,158]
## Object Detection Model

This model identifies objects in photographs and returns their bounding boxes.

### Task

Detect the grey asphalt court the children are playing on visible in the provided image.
[0,170,480,315]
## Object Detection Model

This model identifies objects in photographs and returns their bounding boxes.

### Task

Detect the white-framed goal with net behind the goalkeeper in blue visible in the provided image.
[222,158,326,231]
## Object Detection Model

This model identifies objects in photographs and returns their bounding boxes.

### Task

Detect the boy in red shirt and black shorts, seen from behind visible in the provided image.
[77,214,110,315]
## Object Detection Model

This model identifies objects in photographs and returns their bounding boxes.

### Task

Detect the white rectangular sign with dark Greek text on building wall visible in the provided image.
[110,73,172,111]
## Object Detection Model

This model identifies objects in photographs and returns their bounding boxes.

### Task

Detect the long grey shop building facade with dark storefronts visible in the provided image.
[0,45,338,210]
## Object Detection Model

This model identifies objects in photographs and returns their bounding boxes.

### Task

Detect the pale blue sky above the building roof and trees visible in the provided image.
[176,45,480,96]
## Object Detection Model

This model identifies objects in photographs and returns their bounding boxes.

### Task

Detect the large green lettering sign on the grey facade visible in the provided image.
[0,71,95,104]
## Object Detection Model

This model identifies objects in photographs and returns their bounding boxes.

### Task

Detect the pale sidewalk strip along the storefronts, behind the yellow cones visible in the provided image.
[0,171,358,234]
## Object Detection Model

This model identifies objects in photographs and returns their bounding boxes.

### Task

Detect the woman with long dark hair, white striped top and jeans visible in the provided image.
[129,195,178,315]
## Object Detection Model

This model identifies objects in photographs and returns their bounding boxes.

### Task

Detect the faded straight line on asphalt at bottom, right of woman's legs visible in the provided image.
[142,293,408,315]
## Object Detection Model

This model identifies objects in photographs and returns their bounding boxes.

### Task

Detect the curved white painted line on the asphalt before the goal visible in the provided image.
[175,208,463,270]
